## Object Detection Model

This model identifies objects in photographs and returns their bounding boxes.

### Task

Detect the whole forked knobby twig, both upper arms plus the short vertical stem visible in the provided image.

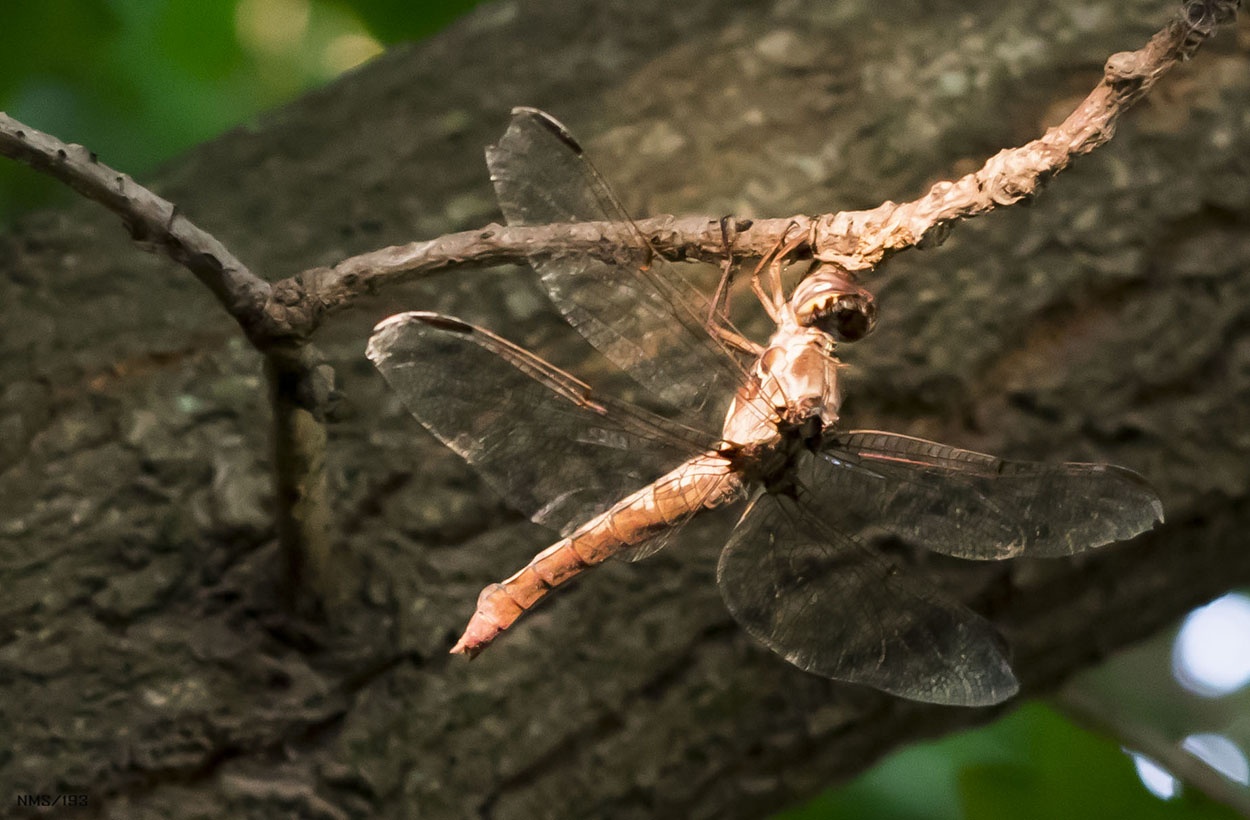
[0,0,1240,615]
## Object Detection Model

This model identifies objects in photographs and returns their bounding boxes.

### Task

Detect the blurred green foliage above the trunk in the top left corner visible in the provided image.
[0,0,479,224]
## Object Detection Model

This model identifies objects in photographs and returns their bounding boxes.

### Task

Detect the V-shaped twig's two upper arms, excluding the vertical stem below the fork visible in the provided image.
[0,0,1240,346]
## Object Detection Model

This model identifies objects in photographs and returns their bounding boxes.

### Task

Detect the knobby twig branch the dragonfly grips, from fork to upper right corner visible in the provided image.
[290,0,1240,334]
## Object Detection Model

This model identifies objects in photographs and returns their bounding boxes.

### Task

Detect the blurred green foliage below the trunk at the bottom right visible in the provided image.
[774,703,1236,820]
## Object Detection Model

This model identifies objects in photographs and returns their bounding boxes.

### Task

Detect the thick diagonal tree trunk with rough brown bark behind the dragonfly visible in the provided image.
[0,0,1250,818]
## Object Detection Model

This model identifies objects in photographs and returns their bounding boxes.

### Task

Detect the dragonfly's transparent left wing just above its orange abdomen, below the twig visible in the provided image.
[369,313,714,534]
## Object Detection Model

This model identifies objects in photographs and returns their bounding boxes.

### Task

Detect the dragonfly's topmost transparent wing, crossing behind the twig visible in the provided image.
[486,108,743,425]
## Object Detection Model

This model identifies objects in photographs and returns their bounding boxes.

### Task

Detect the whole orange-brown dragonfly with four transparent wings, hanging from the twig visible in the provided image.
[368,108,1163,706]
